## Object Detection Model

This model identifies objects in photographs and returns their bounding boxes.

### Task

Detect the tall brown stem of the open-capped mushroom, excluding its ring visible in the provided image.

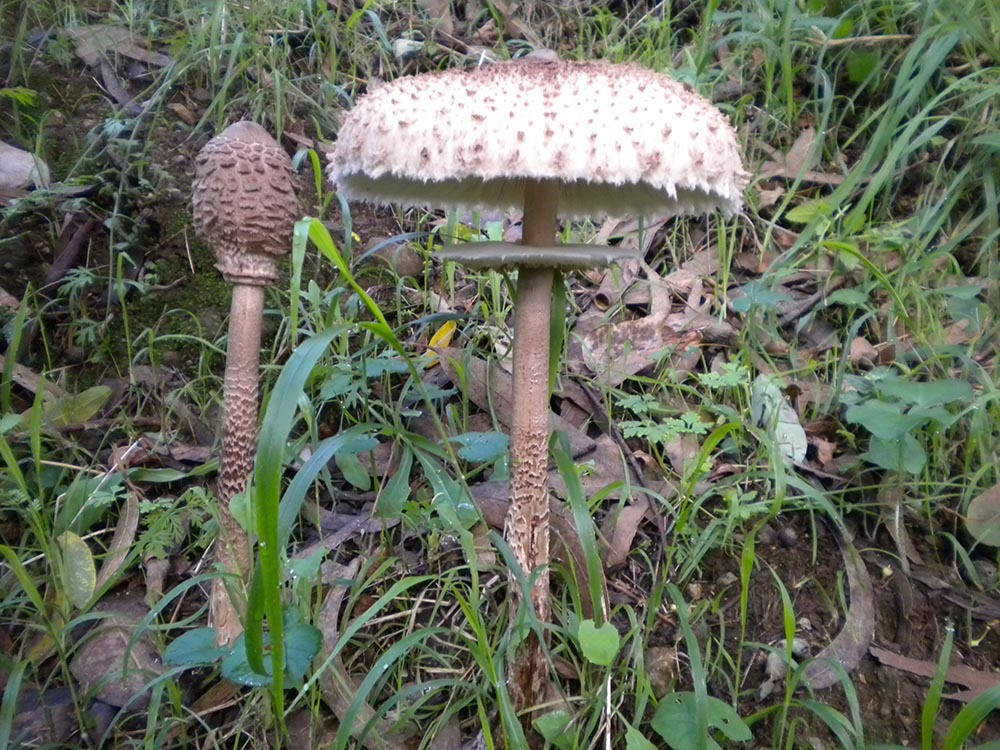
[507,180,559,710]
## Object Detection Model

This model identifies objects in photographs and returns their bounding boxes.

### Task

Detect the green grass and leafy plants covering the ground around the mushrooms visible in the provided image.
[0,0,1000,750]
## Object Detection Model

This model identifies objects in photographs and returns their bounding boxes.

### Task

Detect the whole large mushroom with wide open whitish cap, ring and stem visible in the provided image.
[329,62,746,709]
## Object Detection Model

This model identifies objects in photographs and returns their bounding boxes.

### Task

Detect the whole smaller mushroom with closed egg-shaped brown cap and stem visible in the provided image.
[191,122,301,644]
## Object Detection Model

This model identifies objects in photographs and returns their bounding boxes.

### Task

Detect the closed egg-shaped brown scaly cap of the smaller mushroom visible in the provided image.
[191,121,301,285]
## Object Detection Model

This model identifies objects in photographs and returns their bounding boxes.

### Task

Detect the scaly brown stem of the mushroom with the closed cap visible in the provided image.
[210,283,265,644]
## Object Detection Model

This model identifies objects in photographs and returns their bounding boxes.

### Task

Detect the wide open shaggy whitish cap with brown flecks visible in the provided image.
[329,62,746,217]
